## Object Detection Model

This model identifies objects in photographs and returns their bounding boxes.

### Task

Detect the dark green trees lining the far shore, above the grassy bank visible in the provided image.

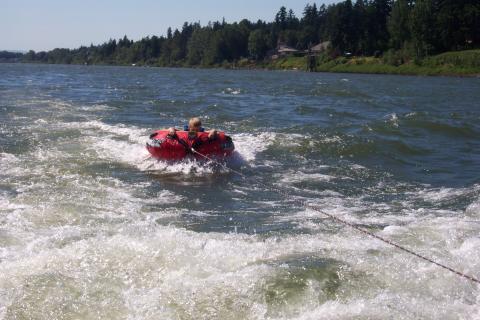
[16,0,480,66]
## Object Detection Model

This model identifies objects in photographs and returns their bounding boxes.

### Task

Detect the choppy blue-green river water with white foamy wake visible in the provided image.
[0,65,480,319]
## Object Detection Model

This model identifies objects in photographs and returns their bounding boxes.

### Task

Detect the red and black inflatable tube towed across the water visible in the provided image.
[147,130,235,160]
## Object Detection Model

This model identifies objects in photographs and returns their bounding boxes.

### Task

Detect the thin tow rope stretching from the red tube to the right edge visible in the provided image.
[191,148,480,284]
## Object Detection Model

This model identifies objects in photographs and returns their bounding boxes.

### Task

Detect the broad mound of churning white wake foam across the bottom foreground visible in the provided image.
[4,218,478,319]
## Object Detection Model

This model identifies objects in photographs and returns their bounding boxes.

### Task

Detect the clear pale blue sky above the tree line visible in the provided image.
[0,0,336,51]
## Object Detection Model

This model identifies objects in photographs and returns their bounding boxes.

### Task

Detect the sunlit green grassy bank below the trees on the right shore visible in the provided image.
[251,50,480,76]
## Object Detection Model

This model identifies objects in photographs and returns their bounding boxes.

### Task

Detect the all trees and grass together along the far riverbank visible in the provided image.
[4,0,480,74]
